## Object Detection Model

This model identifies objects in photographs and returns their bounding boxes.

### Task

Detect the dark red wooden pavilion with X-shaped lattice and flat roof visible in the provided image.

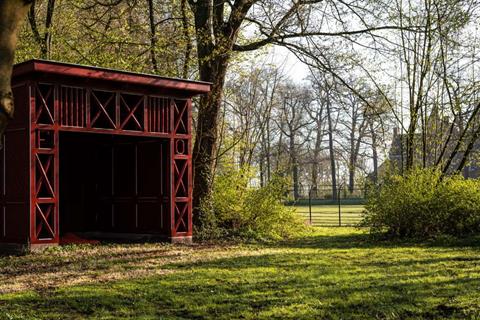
[0,60,210,250]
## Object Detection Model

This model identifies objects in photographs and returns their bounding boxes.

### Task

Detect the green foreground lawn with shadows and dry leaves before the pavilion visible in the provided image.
[0,228,480,320]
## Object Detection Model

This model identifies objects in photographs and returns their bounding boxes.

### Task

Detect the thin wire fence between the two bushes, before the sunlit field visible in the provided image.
[287,185,366,227]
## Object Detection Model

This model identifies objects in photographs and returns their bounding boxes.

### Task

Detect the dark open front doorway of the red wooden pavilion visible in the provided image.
[59,132,170,237]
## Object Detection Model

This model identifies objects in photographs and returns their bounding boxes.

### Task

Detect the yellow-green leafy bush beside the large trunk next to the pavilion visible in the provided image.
[200,169,304,239]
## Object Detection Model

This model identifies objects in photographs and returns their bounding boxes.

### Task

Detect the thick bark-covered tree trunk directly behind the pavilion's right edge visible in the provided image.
[189,0,253,228]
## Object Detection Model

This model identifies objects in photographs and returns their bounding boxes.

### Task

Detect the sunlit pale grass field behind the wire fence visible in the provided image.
[295,204,364,226]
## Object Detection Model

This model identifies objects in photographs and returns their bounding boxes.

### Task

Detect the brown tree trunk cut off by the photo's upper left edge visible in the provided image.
[0,0,31,146]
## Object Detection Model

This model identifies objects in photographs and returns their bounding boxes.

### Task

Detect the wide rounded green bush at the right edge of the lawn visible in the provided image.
[362,169,480,237]
